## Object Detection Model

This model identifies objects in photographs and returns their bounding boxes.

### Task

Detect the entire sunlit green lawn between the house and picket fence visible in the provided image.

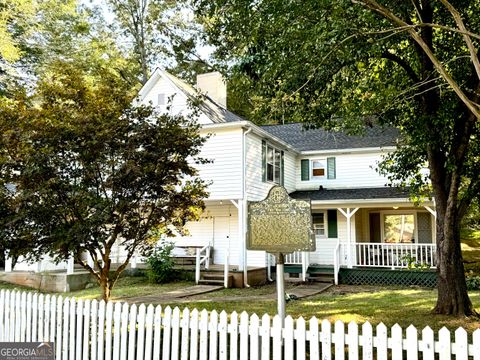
[0,277,480,332]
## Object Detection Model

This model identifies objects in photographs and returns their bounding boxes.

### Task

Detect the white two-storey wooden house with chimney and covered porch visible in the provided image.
[4,69,436,290]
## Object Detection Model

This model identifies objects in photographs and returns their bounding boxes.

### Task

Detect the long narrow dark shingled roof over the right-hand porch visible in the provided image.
[290,186,409,201]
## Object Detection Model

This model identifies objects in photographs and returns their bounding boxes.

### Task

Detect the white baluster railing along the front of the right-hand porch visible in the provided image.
[339,243,437,269]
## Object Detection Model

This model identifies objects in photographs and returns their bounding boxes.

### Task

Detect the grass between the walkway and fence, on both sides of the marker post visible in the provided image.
[158,285,480,332]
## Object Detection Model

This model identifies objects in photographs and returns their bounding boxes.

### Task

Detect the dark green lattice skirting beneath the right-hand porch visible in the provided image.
[339,268,437,288]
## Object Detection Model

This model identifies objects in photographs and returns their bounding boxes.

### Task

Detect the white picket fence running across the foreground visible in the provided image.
[0,290,480,360]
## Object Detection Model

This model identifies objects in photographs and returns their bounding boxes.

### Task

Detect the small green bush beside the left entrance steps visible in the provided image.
[147,242,175,284]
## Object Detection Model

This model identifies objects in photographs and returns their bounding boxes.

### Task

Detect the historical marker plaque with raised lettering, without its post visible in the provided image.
[247,186,315,254]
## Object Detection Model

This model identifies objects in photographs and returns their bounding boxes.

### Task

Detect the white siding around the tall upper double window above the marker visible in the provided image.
[246,133,296,201]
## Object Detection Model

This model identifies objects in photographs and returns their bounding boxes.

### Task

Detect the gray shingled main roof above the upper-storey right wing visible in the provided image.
[262,123,400,151]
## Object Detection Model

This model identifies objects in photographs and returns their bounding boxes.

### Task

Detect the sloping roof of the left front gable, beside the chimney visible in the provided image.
[163,71,244,123]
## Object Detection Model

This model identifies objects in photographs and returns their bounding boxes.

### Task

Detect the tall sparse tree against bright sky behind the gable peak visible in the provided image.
[107,0,209,84]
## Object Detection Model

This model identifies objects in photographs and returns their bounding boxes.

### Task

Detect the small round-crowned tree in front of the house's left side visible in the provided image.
[0,61,207,300]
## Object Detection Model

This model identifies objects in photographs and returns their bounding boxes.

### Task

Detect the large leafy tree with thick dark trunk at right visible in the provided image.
[196,0,480,315]
